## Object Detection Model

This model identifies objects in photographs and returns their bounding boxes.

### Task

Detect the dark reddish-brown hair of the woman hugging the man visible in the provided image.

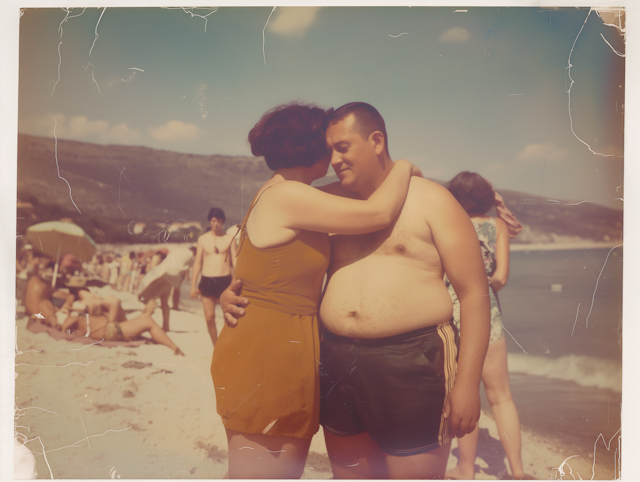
[249,103,329,171]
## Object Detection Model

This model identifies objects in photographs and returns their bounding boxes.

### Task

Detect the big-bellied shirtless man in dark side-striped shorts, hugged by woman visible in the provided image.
[223,103,490,479]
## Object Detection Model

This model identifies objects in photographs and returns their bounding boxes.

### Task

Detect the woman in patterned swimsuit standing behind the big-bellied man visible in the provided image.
[446,171,531,480]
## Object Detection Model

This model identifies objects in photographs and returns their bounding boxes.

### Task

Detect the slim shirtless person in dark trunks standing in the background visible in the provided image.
[191,208,237,346]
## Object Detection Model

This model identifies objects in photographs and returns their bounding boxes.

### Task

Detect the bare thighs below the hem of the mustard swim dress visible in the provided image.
[227,429,311,479]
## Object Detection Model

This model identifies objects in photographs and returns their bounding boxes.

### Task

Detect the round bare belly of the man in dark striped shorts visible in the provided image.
[320,255,453,338]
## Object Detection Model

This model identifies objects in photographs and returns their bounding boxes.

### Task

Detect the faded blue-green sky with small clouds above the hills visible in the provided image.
[18,7,625,208]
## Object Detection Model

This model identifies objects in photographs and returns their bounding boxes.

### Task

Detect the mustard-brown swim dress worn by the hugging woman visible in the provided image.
[211,191,331,438]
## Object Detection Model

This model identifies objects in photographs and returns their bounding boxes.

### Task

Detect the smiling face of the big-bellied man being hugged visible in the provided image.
[327,114,380,192]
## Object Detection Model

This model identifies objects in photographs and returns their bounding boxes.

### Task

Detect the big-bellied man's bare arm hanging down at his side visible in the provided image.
[424,183,491,437]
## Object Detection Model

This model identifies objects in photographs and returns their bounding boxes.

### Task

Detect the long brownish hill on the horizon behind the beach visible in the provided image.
[17,134,622,247]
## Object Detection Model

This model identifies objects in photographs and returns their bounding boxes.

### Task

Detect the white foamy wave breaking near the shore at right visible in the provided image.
[508,353,622,392]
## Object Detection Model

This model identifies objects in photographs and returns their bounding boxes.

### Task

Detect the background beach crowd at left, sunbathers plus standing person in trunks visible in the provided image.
[16,213,242,356]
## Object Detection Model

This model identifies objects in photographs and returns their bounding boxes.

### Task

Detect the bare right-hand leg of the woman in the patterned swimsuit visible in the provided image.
[482,337,525,479]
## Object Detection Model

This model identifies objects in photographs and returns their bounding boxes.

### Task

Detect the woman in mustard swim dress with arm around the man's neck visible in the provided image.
[211,104,419,479]
